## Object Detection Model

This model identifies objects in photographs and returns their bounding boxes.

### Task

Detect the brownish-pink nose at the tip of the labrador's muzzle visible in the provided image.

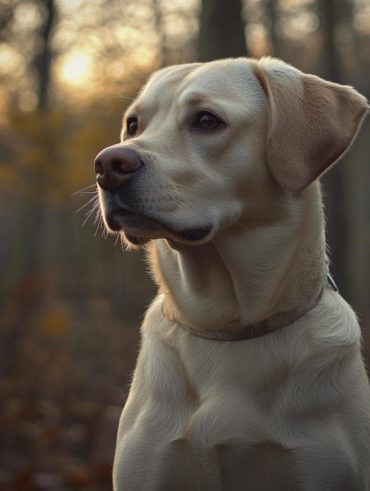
[95,144,142,191]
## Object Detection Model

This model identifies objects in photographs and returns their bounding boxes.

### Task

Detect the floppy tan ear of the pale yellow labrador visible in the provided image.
[254,59,368,191]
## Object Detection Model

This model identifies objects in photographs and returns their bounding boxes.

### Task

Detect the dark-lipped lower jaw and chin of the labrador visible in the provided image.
[104,210,213,247]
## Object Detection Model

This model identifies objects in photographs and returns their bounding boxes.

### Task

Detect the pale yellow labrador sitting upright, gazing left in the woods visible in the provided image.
[95,58,370,491]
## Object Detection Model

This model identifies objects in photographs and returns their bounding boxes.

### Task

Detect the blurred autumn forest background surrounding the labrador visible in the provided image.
[0,0,370,491]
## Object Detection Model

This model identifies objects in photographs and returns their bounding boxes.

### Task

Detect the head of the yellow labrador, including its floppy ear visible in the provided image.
[95,58,367,248]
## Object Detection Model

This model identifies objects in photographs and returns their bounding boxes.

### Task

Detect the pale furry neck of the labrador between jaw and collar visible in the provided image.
[151,184,326,331]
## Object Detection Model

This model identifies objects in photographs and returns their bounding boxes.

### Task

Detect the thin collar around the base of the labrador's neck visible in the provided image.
[171,272,338,341]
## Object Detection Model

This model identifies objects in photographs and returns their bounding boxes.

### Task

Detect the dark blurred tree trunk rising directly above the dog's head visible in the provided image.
[198,0,247,61]
